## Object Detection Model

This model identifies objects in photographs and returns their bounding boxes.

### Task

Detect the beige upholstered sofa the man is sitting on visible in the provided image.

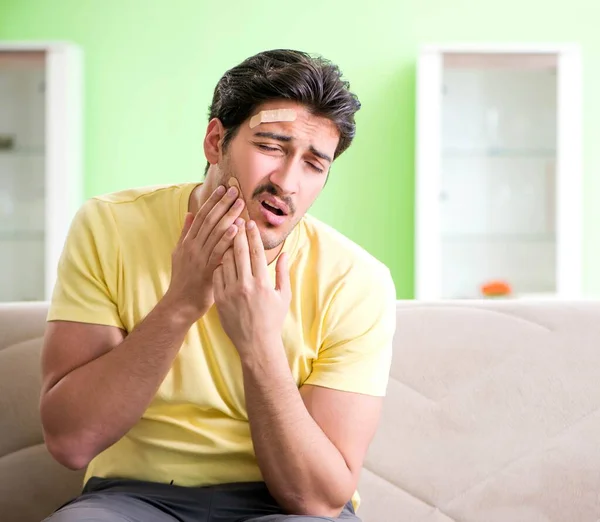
[0,300,600,522]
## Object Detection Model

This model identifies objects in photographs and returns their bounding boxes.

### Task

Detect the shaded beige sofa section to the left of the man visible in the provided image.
[0,303,83,522]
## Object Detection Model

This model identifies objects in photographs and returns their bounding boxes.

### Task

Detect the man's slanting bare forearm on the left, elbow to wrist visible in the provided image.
[41,301,195,467]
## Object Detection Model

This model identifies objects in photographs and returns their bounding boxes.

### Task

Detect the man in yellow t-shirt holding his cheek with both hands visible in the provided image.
[41,50,395,522]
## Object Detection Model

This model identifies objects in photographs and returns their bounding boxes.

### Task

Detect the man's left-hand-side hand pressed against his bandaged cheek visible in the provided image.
[165,186,244,323]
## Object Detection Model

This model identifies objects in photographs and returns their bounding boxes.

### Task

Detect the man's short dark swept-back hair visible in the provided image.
[207,49,360,170]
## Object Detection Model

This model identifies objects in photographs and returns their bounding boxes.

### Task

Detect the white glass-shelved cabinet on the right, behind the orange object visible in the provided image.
[415,45,582,300]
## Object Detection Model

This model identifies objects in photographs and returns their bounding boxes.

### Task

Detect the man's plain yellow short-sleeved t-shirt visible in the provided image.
[48,183,396,506]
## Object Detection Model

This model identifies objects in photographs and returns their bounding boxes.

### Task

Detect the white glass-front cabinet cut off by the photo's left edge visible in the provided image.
[0,41,82,302]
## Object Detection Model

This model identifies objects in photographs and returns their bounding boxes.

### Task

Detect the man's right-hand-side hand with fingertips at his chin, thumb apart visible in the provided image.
[213,217,291,358]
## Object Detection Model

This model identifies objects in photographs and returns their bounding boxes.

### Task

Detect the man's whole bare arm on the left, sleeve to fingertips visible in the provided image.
[40,187,250,469]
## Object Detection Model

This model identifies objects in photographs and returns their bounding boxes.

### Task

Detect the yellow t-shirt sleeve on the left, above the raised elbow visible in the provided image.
[47,199,124,329]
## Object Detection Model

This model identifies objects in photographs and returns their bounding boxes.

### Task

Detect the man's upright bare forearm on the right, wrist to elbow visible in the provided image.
[242,343,353,516]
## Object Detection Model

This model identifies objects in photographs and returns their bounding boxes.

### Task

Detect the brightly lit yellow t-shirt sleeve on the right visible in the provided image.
[305,265,396,396]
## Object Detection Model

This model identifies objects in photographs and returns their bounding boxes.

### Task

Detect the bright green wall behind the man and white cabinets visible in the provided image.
[0,0,600,298]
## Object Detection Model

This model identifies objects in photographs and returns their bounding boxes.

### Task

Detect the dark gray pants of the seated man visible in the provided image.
[44,477,360,522]
